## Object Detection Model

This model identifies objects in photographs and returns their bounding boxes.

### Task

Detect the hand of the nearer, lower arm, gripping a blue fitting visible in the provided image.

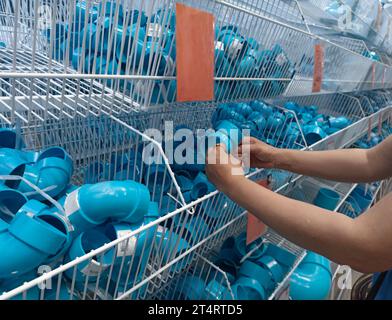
[206,145,245,193]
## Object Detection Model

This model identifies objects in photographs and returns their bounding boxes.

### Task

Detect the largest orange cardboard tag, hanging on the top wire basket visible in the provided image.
[176,3,214,102]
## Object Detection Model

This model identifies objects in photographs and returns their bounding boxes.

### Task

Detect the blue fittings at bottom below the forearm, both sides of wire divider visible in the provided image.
[156,233,332,300]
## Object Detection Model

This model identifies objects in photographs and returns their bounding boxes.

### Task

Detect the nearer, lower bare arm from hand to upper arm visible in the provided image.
[207,146,392,273]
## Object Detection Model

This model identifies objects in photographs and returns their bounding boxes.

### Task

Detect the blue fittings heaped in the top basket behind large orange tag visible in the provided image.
[45,1,295,104]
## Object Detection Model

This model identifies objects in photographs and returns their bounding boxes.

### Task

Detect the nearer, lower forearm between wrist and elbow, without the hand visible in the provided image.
[224,179,370,267]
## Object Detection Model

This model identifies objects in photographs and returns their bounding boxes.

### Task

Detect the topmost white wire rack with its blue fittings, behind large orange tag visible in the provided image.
[0,0,392,117]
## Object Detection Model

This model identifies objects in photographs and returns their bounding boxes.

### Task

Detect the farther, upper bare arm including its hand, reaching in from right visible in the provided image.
[240,137,392,182]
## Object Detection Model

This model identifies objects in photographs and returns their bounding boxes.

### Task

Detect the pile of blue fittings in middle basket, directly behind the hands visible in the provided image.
[212,101,351,148]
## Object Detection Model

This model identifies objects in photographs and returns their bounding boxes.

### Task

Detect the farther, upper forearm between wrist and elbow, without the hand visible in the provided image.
[275,149,375,182]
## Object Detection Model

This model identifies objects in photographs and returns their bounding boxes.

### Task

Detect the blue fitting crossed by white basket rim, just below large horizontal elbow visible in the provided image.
[64,229,116,285]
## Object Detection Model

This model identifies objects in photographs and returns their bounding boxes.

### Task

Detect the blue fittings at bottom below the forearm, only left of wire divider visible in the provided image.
[168,233,296,300]
